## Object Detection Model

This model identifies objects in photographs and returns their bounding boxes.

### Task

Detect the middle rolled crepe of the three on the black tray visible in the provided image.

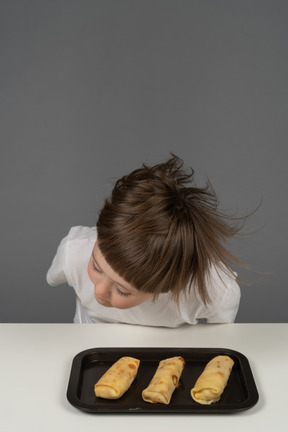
[142,357,185,405]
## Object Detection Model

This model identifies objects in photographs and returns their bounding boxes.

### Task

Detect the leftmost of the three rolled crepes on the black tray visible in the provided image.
[94,357,140,399]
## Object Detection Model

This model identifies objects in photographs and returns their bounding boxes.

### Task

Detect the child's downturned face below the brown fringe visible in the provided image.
[88,242,152,309]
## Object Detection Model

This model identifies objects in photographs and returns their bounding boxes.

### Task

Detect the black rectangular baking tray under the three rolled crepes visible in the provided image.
[67,347,259,414]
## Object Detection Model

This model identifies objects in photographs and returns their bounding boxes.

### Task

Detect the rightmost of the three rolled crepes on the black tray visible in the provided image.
[191,356,234,405]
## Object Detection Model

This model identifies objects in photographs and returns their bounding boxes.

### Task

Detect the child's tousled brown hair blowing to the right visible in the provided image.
[97,154,248,303]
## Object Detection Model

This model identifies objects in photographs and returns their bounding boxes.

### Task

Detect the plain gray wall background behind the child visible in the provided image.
[0,0,288,322]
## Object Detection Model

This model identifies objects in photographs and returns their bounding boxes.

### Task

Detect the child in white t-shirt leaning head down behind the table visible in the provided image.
[47,155,240,327]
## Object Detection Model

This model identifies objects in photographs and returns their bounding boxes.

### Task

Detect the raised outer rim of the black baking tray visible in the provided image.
[66,346,259,414]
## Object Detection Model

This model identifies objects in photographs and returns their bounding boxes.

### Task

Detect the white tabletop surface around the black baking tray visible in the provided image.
[0,324,288,432]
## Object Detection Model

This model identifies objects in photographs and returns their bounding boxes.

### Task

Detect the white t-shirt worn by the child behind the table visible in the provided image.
[47,226,240,327]
